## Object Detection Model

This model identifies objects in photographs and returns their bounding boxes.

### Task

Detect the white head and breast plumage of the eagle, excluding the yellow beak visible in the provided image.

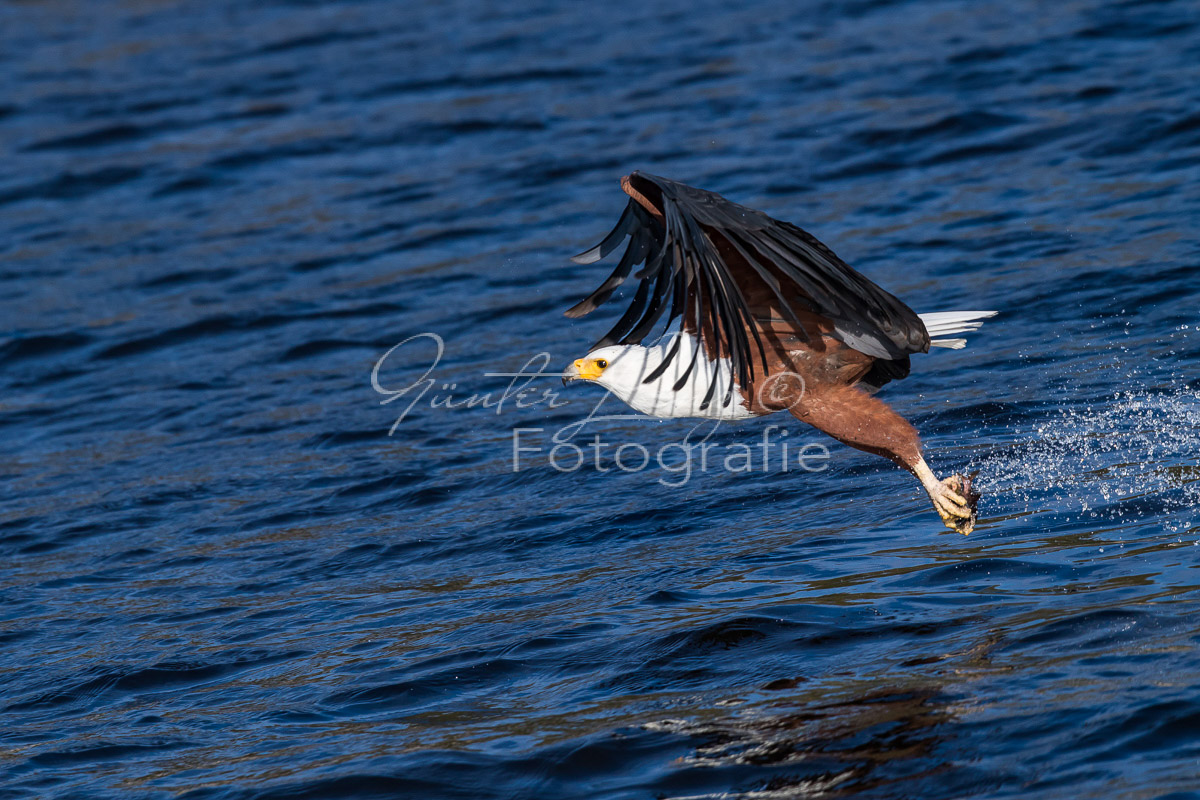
[588,332,755,420]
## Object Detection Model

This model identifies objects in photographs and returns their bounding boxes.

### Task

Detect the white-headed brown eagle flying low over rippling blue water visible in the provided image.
[563,172,996,534]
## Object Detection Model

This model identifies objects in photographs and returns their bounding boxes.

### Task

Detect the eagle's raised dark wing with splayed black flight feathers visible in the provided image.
[566,173,929,405]
